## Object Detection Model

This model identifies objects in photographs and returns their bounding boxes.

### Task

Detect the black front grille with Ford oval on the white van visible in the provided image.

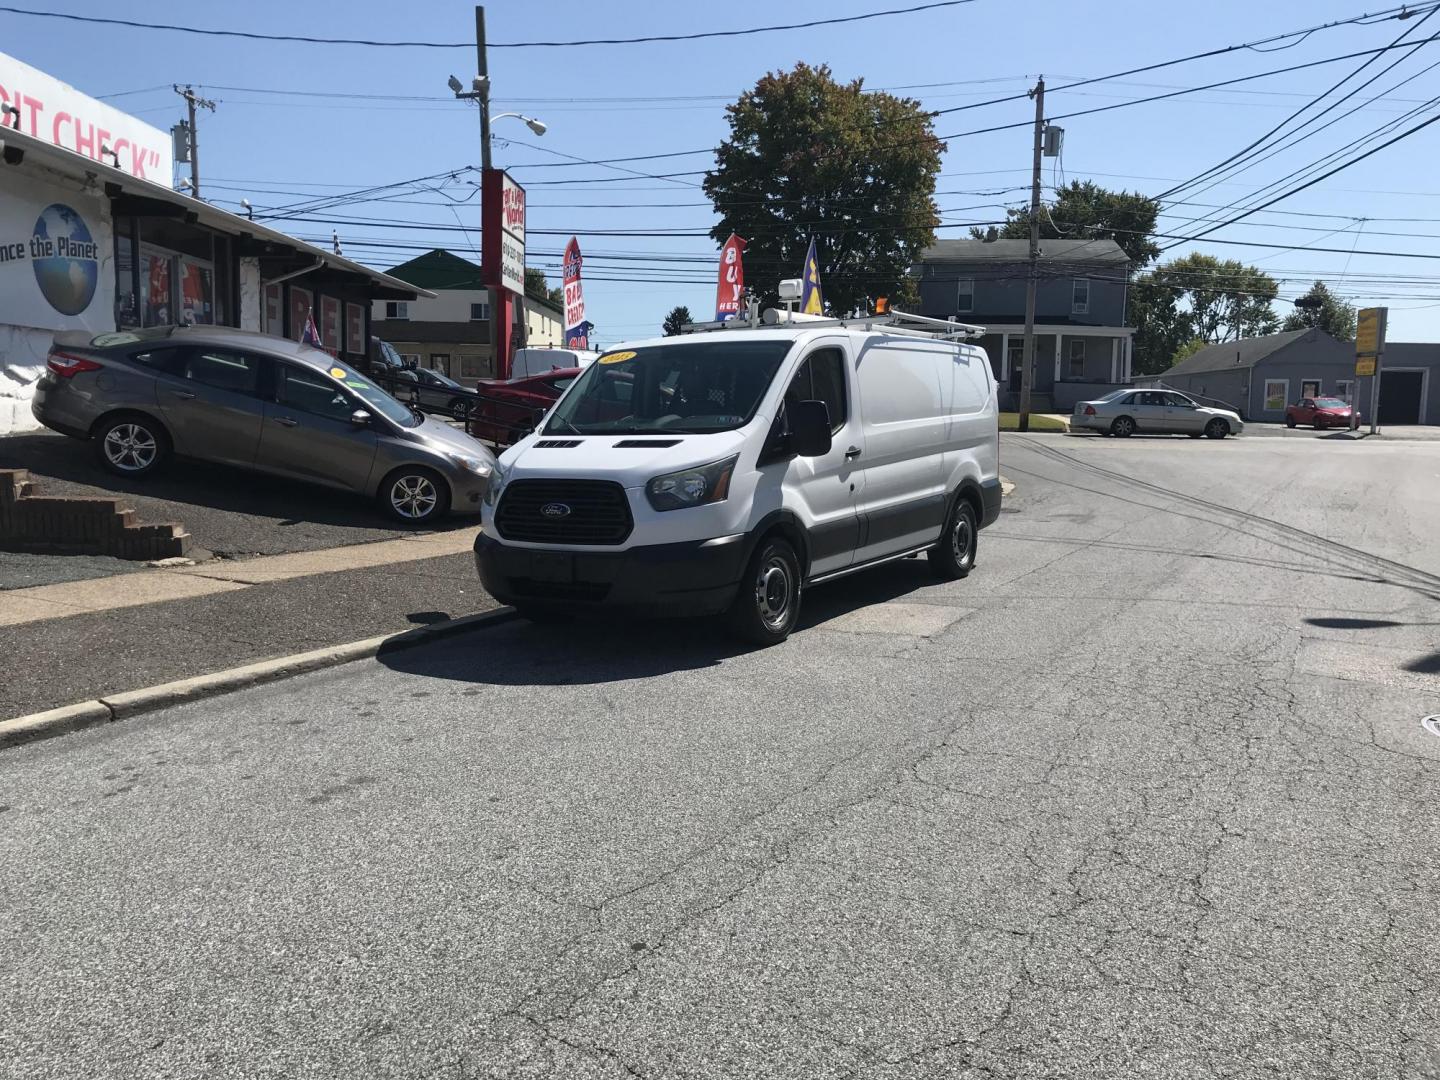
[495,480,635,544]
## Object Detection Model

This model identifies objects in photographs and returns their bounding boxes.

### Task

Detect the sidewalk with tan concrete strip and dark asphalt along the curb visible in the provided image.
[0,528,497,720]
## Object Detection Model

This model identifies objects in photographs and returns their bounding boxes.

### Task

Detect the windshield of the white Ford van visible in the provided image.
[546,336,792,435]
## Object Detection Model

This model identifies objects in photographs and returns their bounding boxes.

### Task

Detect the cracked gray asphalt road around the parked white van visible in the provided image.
[0,436,1440,1080]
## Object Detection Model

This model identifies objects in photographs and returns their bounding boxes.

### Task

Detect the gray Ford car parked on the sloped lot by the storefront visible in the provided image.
[32,327,495,524]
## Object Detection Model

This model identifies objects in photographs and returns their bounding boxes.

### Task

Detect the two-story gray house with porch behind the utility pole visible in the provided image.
[916,239,1135,412]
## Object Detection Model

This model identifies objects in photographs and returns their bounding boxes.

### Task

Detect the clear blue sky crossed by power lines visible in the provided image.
[11,0,1440,344]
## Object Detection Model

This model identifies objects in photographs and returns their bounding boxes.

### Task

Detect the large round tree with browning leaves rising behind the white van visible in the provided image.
[704,63,945,311]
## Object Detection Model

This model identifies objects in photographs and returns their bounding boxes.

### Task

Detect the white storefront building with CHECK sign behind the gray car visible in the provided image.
[0,55,431,435]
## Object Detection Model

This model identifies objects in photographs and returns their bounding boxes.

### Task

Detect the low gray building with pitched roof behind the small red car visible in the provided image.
[1136,328,1440,423]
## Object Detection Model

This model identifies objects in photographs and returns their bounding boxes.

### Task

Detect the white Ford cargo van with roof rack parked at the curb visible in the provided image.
[475,311,1001,645]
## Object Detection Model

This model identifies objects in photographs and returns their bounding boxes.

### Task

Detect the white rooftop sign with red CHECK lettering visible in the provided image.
[0,53,174,187]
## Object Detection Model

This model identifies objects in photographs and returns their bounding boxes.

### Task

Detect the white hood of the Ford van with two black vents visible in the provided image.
[500,428,747,488]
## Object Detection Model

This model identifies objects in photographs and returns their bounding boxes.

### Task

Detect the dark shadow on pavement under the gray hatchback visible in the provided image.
[0,432,468,538]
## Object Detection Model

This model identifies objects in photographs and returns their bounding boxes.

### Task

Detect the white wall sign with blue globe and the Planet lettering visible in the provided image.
[0,170,115,331]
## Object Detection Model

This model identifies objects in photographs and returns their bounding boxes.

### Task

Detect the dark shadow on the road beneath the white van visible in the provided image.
[376,559,936,687]
